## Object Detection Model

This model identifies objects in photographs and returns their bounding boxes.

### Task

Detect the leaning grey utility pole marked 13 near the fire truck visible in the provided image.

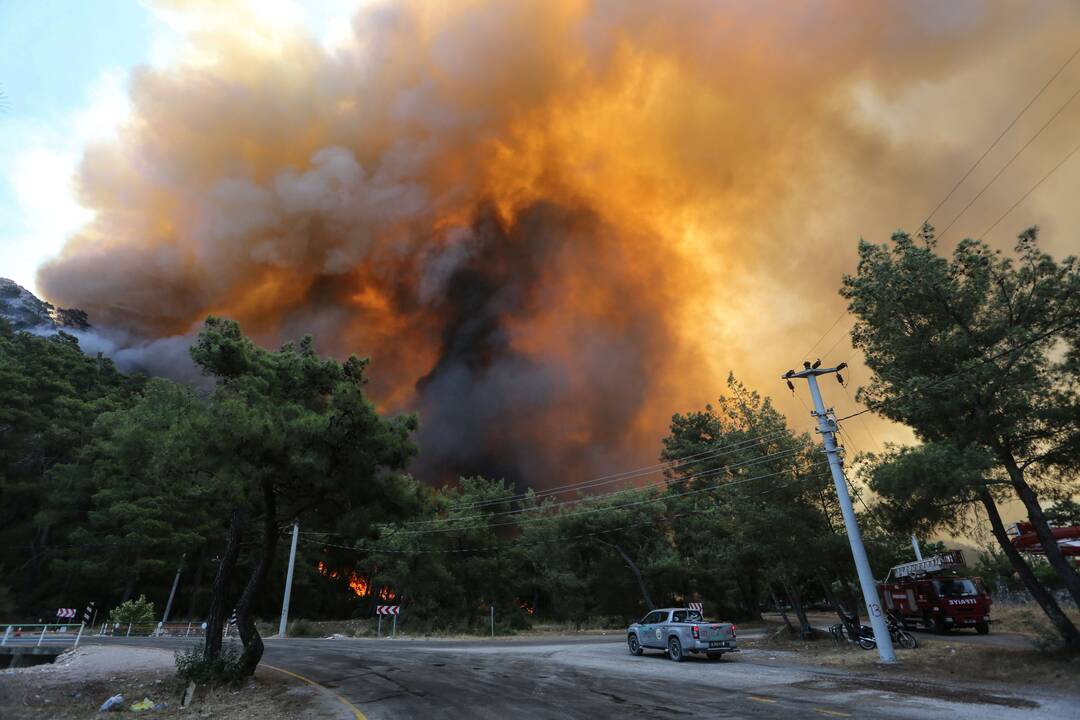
[782,361,896,663]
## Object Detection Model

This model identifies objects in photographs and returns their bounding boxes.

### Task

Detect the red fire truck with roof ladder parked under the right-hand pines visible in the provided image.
[878,551,990,635]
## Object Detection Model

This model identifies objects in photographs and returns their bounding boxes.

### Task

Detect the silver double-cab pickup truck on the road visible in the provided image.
[626,608,739,663]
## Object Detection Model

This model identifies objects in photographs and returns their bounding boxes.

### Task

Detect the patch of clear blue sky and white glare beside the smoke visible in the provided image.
[0,0,153,289]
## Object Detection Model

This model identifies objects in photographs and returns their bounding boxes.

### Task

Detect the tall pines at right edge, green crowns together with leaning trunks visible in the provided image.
[841,225,1080,649]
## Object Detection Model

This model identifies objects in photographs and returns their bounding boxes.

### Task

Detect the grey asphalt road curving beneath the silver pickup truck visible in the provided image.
[79,636,1080,720]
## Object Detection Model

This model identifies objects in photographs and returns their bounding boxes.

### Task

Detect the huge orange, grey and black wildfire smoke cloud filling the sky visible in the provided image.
[0,0,1080,486]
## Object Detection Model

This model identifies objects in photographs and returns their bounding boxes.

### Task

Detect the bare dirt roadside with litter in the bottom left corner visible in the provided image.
[0,646,352,720]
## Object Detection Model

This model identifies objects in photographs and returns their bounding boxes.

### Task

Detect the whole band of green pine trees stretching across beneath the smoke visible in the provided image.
[0,228,1080,669]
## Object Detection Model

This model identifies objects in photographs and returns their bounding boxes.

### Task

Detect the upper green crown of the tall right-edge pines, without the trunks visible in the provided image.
[841,227,1080,491]
